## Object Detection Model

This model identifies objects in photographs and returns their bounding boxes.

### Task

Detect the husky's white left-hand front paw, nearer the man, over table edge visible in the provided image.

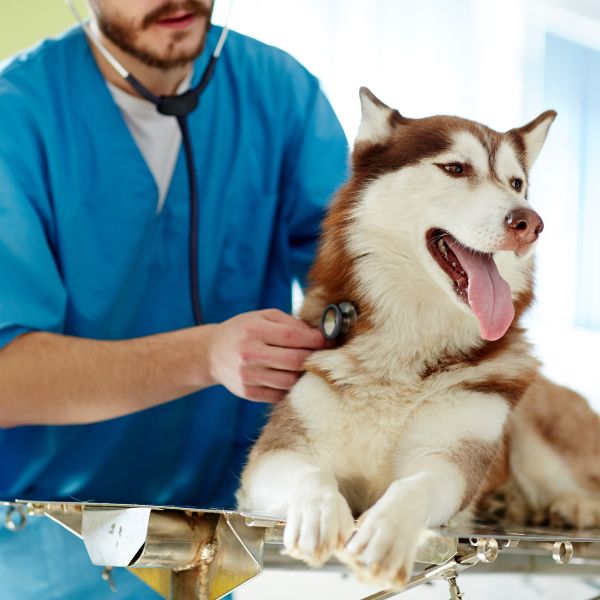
[283,491,355,566]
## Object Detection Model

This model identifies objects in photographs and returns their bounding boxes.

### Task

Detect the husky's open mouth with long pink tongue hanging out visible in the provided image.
[425,228,515,340]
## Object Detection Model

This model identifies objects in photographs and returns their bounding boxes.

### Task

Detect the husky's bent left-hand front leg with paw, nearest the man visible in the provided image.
[238,450,354,566]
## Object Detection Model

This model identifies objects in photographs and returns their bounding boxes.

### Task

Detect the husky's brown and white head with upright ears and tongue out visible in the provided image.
[312,88,556,340]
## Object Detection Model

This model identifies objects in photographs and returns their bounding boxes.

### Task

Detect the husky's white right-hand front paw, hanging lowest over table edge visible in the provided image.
[338,506,425,588]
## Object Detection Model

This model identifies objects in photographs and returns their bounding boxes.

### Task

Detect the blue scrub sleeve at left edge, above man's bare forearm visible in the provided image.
[0,113,67,348]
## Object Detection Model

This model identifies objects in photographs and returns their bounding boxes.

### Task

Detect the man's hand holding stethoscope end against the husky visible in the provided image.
[209,309,327,402]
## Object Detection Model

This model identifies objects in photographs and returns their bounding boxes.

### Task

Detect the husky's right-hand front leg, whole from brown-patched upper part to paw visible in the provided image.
[340,394,508,587]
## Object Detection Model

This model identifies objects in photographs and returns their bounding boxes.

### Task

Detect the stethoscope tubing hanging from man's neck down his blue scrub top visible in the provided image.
[66,0,233,325]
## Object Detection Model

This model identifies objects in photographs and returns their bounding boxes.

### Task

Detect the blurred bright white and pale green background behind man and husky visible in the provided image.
[0,0,600,600]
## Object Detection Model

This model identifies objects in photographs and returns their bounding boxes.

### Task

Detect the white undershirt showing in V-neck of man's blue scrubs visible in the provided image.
[107,71,193,213]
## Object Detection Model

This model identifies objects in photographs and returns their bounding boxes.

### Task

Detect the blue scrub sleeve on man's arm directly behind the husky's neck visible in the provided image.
[285,80,348,287]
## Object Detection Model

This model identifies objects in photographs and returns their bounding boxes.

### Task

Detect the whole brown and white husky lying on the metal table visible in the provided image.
[238,88,600,585]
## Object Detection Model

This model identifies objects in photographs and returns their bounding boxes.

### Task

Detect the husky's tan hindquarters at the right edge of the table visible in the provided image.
[473,375,600,528]
